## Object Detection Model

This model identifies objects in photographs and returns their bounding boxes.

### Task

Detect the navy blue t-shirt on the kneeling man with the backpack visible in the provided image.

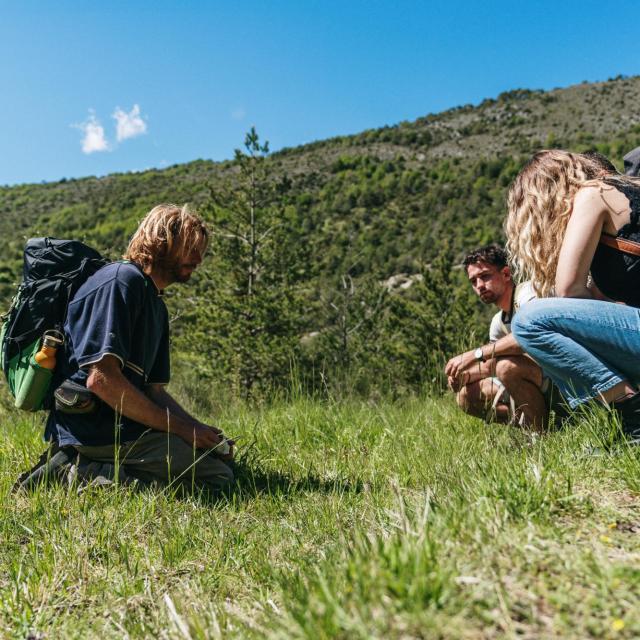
[45,262,169,446]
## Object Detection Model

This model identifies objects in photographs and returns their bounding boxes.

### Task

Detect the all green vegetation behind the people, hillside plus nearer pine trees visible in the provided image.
[0,78,640,399]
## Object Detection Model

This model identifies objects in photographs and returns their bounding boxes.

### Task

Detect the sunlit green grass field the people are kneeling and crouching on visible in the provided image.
[0,398,640,639]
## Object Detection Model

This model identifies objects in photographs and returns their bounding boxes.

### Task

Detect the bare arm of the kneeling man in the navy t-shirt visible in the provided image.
[87,355,221,449]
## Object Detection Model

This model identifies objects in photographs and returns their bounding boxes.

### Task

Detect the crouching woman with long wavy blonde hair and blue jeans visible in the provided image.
[506,150,640,443]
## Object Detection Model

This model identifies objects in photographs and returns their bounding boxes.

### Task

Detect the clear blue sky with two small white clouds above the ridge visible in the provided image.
[0,0,640,184]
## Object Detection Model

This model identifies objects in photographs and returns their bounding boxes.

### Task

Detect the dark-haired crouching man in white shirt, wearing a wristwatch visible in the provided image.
[445,245,550,429]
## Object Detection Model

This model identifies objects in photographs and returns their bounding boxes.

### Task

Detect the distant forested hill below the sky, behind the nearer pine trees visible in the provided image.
[0,77,640,396]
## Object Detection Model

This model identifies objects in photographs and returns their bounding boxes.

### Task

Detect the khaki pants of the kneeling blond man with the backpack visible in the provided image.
[74,431,233,493]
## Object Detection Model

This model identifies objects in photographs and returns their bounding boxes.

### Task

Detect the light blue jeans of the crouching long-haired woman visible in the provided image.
[511,298,640,408]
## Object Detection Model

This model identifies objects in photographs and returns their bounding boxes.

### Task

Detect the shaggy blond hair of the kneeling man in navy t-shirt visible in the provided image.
[123,204,209,270]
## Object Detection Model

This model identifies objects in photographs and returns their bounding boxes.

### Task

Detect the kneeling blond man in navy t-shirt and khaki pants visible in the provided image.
[31,205,233,493]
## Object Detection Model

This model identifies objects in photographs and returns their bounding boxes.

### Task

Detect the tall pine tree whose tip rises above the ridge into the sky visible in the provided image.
[198,128,299,399]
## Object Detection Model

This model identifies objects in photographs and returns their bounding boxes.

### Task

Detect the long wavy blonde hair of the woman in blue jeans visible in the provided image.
[505,149,624,297]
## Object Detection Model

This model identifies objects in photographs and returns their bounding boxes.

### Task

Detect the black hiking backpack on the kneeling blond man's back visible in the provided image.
[0,238,109,411]
